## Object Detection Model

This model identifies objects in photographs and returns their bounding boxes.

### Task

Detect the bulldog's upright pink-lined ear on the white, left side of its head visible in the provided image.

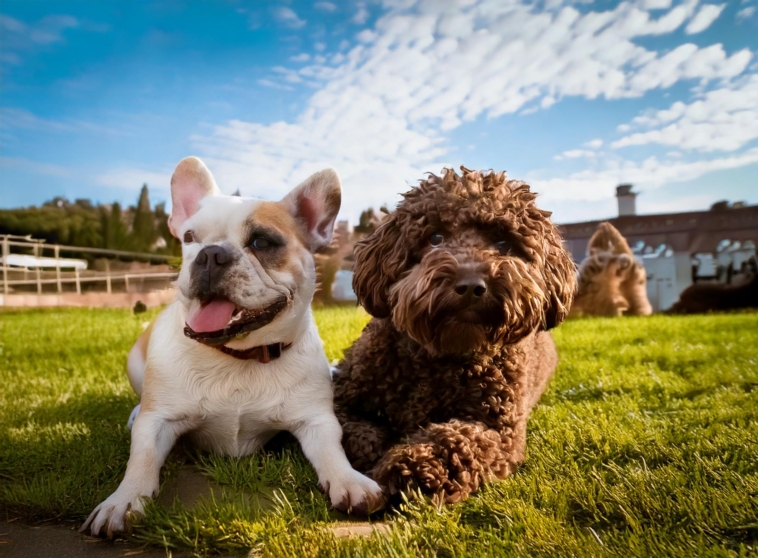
[168,157,221,240]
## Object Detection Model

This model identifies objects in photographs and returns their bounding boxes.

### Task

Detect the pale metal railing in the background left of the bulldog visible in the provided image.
[0,235,177,295]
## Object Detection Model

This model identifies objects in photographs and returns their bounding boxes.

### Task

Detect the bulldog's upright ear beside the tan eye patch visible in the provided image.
[282,169,342,252]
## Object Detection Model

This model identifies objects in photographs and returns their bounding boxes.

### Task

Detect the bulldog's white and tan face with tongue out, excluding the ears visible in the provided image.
[178,196,315,348]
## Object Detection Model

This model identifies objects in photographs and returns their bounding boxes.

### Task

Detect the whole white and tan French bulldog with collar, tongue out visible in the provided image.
[81,157,382,536]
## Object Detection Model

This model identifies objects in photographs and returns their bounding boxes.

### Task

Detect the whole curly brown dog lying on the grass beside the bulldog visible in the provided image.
[334,167,576,508]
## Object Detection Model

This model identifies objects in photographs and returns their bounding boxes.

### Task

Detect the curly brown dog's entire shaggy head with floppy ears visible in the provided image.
[354,169,574,354]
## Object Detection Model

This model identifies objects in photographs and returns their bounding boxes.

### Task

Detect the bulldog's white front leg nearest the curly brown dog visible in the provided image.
[293,414,384,514]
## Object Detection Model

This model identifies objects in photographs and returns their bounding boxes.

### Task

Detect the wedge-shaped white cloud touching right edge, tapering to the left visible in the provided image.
[611,74,758,152]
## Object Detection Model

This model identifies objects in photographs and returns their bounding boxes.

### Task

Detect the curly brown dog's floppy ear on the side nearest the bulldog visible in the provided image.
[353,213,409,318]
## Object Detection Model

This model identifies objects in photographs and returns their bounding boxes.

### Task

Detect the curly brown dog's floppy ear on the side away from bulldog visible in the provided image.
[543,238,576,330]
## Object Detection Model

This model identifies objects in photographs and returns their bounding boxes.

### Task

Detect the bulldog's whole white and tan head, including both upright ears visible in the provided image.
[172,162,340,349]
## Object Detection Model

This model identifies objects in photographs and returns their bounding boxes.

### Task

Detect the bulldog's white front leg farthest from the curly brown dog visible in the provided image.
[79,410,181,537]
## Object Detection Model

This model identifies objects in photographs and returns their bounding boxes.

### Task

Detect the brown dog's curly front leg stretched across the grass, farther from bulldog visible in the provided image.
[371,418,526,503]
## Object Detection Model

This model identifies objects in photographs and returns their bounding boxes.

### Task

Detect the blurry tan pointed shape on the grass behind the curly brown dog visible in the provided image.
[571,222,653,317]
